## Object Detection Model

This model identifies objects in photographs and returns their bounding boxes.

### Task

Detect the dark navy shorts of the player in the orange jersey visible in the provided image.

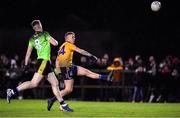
[60,65,77,80]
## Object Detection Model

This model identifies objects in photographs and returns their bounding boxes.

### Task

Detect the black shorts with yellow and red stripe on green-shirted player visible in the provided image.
[36,59,53,76]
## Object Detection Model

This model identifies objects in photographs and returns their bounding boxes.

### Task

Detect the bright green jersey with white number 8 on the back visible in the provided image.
[29,31,51,60]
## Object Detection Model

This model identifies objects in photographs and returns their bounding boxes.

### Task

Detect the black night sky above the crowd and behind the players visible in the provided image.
[0,0,180,58]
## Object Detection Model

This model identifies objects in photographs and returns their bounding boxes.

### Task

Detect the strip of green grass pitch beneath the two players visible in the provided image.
[0,99,180,117]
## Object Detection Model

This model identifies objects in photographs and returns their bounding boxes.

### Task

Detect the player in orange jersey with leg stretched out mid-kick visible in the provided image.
[48,32,113,110]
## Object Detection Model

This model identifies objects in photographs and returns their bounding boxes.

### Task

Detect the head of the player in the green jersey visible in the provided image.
[31,20,43,32]
